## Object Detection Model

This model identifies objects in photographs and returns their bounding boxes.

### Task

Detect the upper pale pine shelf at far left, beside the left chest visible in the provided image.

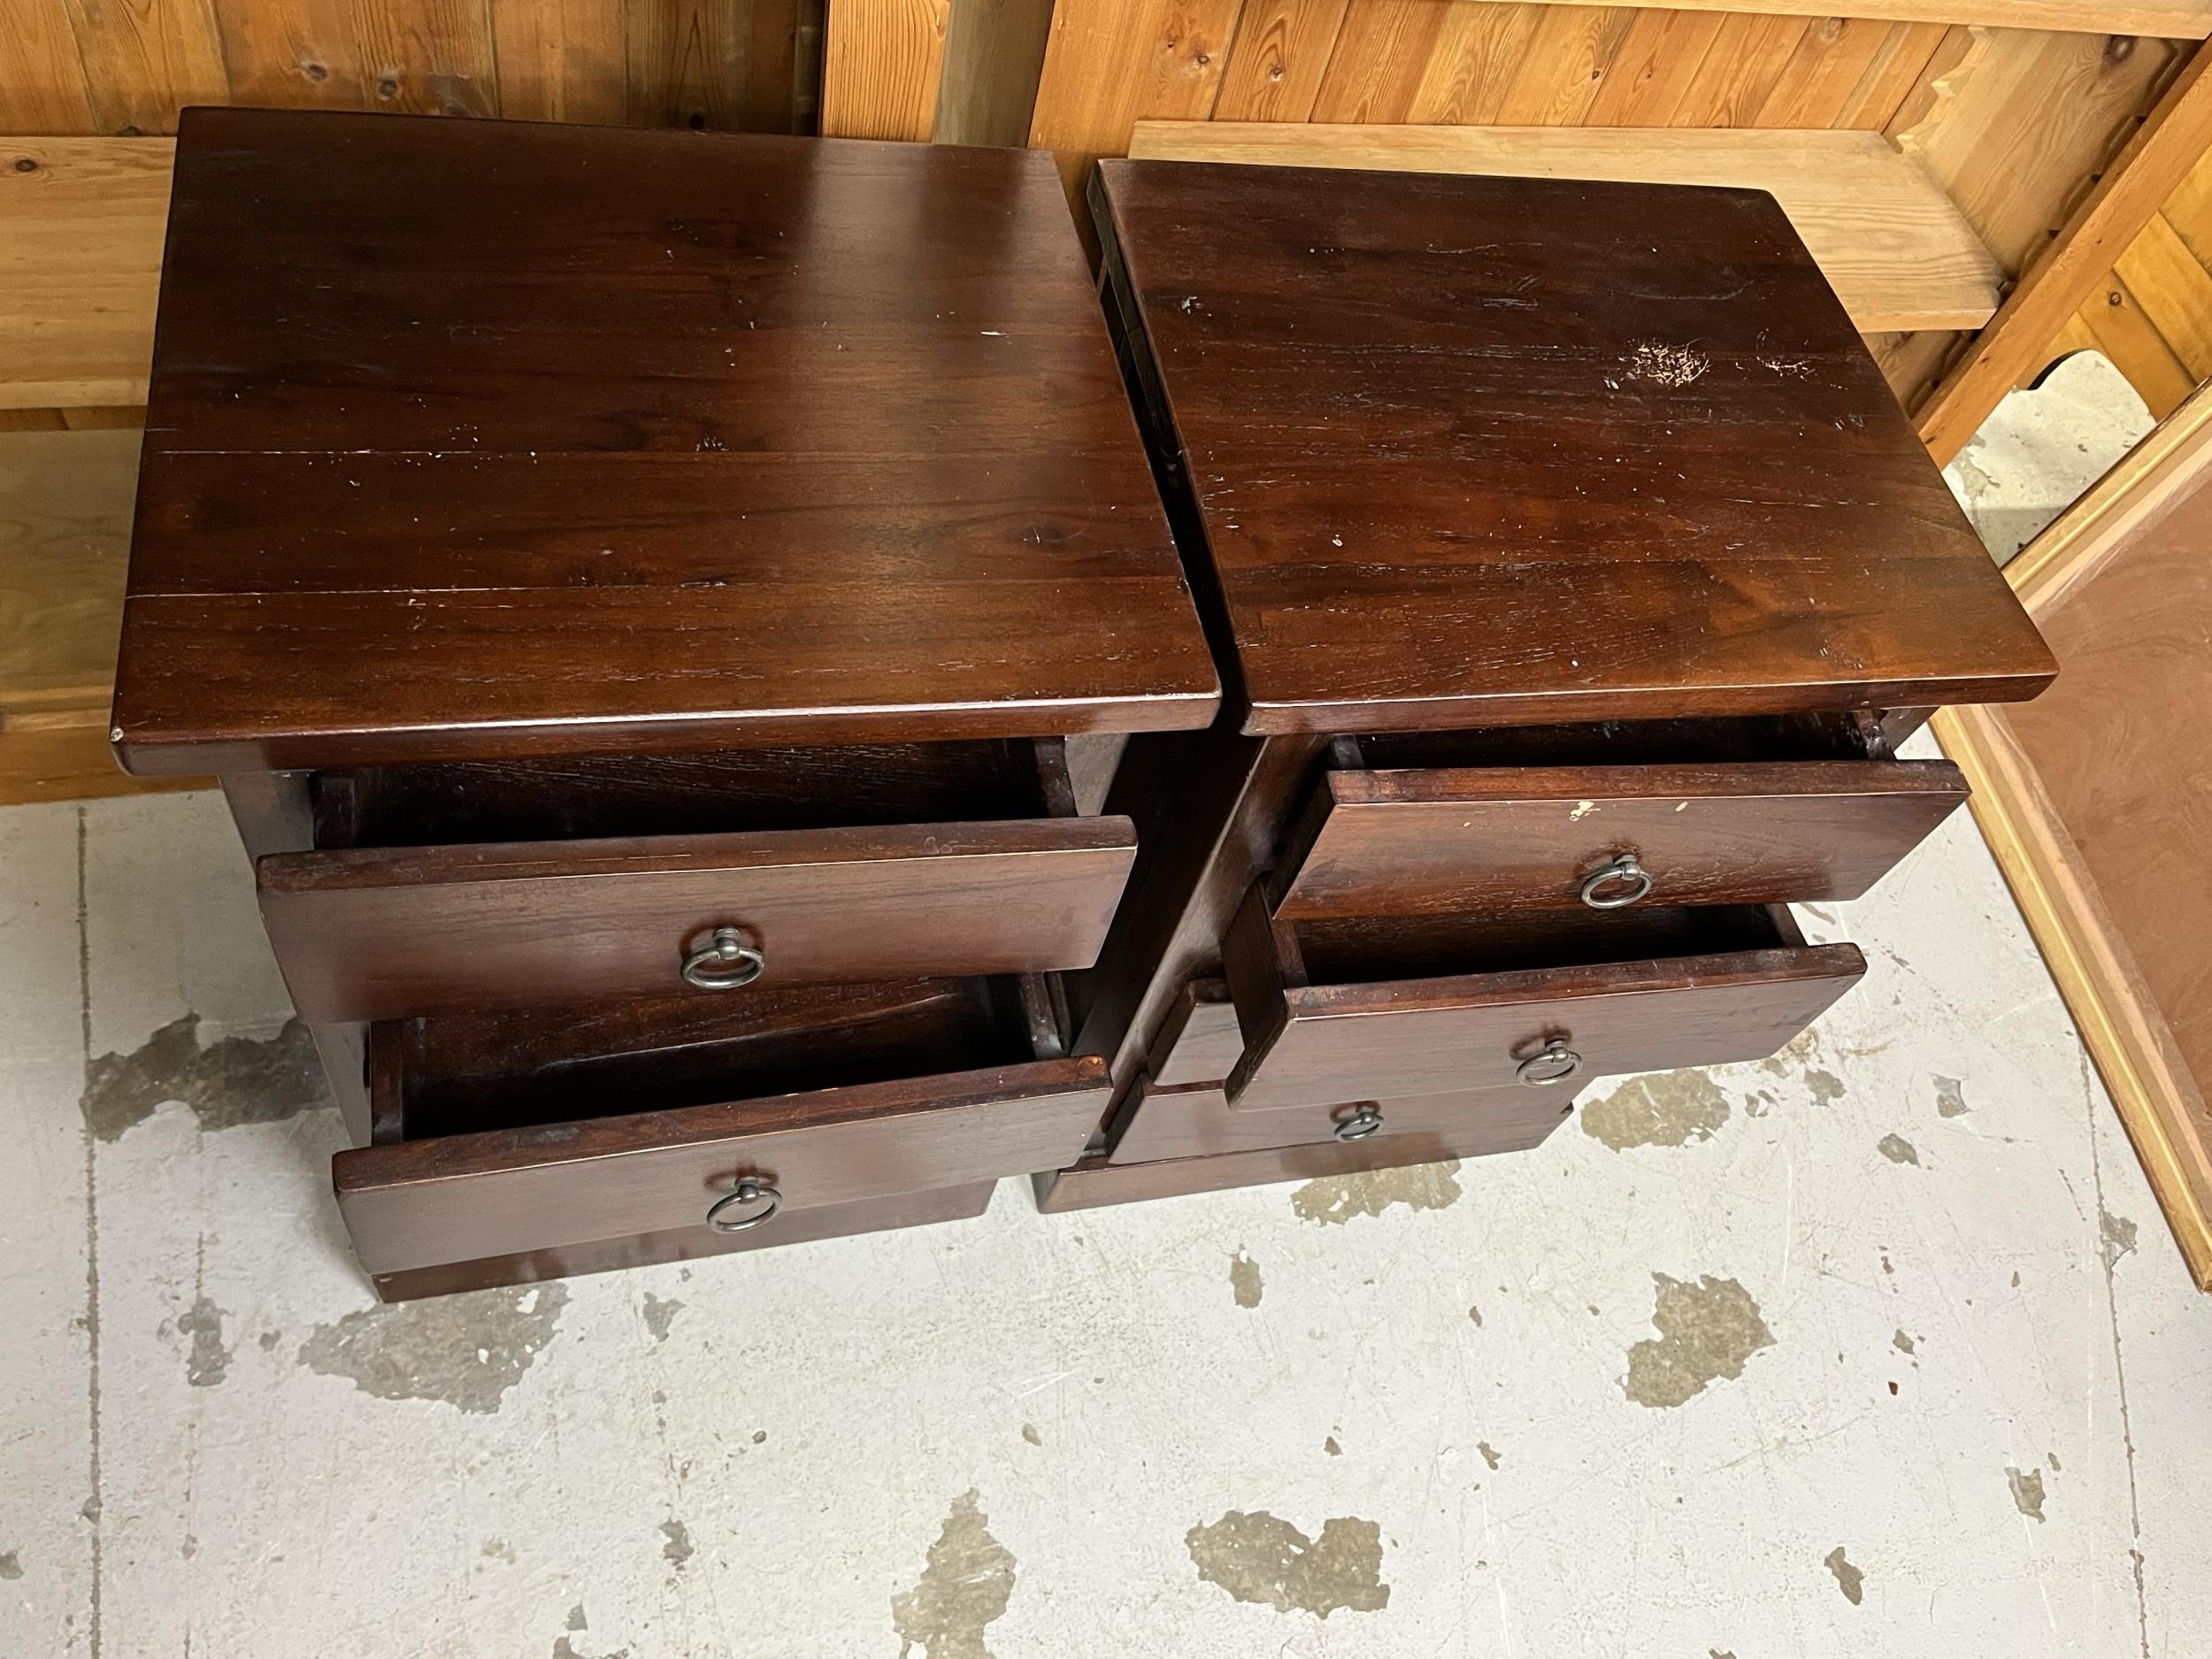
[0,137,177,410]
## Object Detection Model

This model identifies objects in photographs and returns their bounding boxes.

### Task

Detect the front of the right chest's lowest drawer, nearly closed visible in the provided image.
[1106,1084,1573,1164]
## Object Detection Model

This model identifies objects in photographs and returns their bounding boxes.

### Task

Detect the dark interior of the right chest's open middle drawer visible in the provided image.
[1272,905,1805,985]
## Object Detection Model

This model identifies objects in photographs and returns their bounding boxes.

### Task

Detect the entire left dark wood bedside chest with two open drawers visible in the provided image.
[113,111,1219,1299]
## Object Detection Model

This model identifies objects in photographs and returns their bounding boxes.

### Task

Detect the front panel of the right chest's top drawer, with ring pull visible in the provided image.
[1272,761,1967,920]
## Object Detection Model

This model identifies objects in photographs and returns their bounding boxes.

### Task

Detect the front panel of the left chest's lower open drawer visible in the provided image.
[332,1060,1109,1274]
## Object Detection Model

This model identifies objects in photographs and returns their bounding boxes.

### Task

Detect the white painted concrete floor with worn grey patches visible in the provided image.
[0,367,2212,1659]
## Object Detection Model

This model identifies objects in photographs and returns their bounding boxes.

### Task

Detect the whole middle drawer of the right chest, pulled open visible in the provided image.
[1224,885,1867,1110]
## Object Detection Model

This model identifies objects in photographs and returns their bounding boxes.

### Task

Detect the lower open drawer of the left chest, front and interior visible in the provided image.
[332,978,1109,1299]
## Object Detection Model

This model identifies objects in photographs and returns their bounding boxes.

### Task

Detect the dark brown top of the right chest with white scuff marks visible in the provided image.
[1093,162,2053,733]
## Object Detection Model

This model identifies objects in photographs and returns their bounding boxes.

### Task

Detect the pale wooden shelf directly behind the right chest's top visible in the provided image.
[1131,122,2004,334]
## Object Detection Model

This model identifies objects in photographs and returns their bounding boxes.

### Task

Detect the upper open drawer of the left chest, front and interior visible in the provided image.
[255,741,1137,1025]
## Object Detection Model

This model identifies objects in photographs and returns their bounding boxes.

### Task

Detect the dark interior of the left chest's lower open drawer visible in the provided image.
[370,973,1064,1141]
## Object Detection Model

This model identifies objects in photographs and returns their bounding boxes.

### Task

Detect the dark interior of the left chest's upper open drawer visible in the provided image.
[312,737,1088,849]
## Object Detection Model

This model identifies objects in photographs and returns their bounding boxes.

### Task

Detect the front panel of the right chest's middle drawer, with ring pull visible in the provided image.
[1228,945,1867,1110]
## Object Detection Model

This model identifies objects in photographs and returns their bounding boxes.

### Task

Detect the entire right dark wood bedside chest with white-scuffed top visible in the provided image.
[1038,162,2055,1210]
